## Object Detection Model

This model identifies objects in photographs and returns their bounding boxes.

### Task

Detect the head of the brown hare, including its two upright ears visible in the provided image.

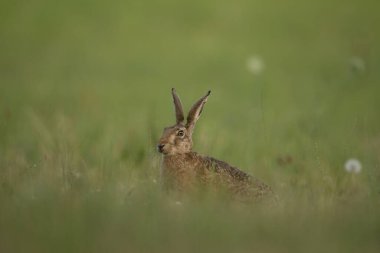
[157,88,211,155]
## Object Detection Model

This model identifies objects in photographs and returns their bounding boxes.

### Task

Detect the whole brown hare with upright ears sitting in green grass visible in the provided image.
[157,88,272,199]
